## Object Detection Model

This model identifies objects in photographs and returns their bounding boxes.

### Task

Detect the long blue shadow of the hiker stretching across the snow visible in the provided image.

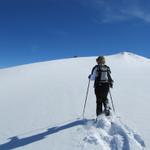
[0,120,87,150]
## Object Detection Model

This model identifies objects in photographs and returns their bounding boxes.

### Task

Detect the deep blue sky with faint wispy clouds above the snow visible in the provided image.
[0,0,150,68]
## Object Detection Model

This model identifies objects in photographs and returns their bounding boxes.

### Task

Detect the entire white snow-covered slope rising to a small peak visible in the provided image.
[0,52,150,150]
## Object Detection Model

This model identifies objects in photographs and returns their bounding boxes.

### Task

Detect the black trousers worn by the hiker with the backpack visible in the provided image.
[95,83,109,116]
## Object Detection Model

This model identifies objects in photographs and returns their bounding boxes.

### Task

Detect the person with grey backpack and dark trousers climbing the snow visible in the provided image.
[88,56,113,116]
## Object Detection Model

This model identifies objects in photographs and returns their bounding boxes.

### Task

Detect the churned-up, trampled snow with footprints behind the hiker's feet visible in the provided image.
[82,116,145,150]
